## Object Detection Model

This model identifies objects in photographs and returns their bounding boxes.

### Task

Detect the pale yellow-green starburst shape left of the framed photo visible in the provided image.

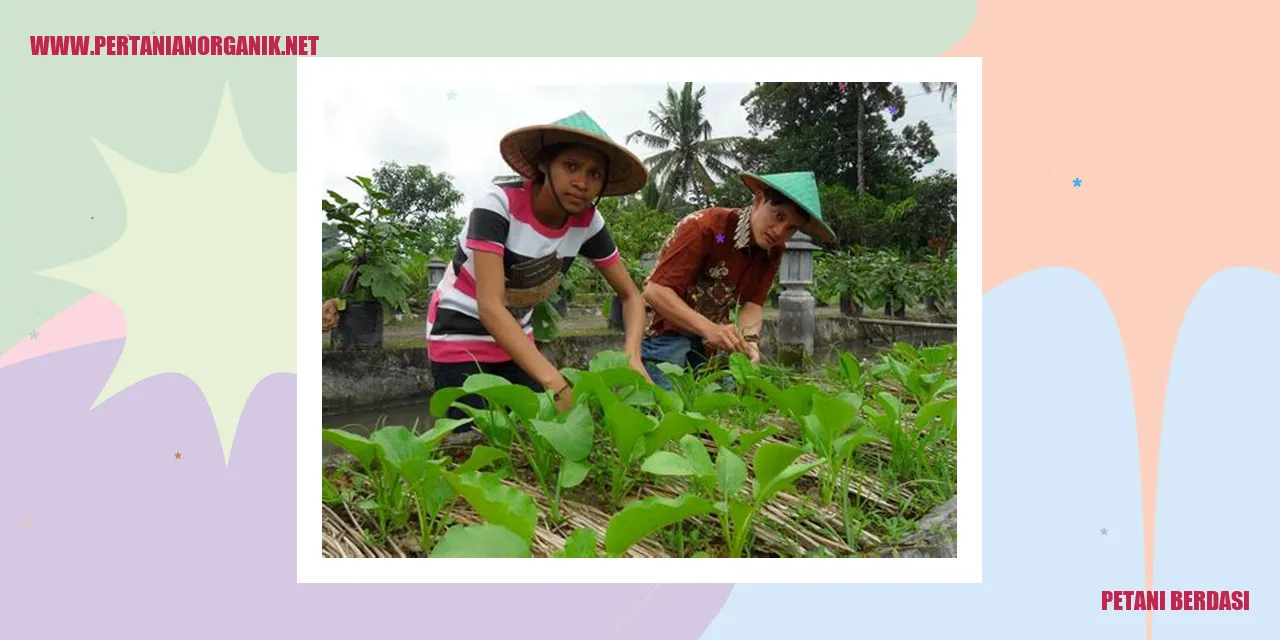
[42,86,297,460]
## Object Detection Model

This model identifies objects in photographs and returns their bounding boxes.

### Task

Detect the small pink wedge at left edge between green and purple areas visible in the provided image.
[0,293,124,367]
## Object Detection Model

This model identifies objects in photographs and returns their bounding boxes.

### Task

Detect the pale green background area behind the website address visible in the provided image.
[0,0,977,453]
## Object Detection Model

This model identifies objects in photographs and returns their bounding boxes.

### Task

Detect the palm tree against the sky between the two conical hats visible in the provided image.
[626,82,739,209]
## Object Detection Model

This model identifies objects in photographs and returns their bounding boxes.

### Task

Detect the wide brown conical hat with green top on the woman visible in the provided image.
[498,111,649,196]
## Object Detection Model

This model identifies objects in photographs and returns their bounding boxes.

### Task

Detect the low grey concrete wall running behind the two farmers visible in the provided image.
[321,317,956,413]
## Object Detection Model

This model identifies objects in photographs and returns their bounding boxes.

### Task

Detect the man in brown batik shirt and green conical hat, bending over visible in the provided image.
[640,172,836,390]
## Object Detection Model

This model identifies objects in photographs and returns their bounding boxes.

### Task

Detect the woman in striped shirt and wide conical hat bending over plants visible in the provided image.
[426,111,649,419]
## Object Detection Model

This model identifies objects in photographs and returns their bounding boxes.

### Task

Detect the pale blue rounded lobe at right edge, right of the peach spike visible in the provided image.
[1152,264,1280,640]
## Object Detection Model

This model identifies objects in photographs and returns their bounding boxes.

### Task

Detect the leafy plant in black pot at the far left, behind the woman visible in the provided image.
[320,175,413,349]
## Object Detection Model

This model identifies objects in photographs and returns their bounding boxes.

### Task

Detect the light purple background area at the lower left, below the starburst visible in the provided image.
[0,340,732,640]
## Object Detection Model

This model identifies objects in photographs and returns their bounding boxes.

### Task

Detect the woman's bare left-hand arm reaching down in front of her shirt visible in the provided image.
[474,251,567,392]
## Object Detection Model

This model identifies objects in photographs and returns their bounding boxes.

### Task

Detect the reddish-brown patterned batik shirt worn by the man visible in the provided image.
[645,207,783,337]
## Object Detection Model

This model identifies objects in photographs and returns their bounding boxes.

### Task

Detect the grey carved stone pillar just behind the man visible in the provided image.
[777,232,818,366]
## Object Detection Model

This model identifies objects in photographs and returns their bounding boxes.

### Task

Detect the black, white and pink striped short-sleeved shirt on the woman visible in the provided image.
[426,180,618,362]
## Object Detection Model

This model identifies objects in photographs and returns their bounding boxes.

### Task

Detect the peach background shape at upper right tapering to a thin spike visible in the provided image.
[943,0,1280,637]
